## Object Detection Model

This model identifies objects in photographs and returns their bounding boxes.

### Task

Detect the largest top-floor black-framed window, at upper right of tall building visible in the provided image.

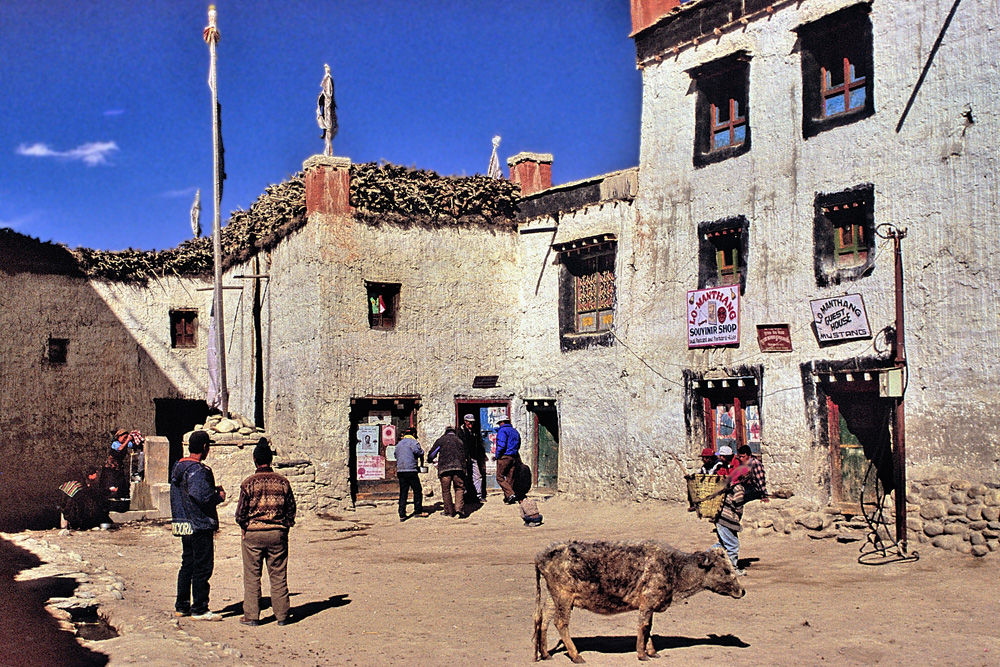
[798,4,875,139]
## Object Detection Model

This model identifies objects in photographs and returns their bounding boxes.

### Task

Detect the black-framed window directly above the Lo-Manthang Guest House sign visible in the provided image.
[814,185,875,287]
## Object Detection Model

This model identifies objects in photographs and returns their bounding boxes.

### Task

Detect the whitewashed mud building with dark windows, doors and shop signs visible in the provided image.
[0,0,1000,552]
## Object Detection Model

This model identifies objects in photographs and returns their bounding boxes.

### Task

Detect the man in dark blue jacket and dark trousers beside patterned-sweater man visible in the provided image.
[170,431,226,621]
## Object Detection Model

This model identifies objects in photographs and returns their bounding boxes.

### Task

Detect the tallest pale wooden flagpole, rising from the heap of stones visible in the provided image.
[202,5,229,417]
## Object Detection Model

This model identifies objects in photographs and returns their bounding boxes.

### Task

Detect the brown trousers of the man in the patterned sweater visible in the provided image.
[243,528,291,621]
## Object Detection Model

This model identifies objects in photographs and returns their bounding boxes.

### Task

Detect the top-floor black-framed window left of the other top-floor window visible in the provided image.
[688,51,750,167]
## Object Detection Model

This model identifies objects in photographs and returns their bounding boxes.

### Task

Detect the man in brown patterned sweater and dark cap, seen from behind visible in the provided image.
[236,438,295,626]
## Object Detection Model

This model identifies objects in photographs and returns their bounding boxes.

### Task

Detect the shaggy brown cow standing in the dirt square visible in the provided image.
[535,541,746,663]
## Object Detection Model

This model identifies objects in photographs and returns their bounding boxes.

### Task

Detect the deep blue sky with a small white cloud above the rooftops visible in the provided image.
[0,0,641,250]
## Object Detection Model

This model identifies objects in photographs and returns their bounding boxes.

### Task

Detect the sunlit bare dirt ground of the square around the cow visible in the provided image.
[0,496,1000,667]
